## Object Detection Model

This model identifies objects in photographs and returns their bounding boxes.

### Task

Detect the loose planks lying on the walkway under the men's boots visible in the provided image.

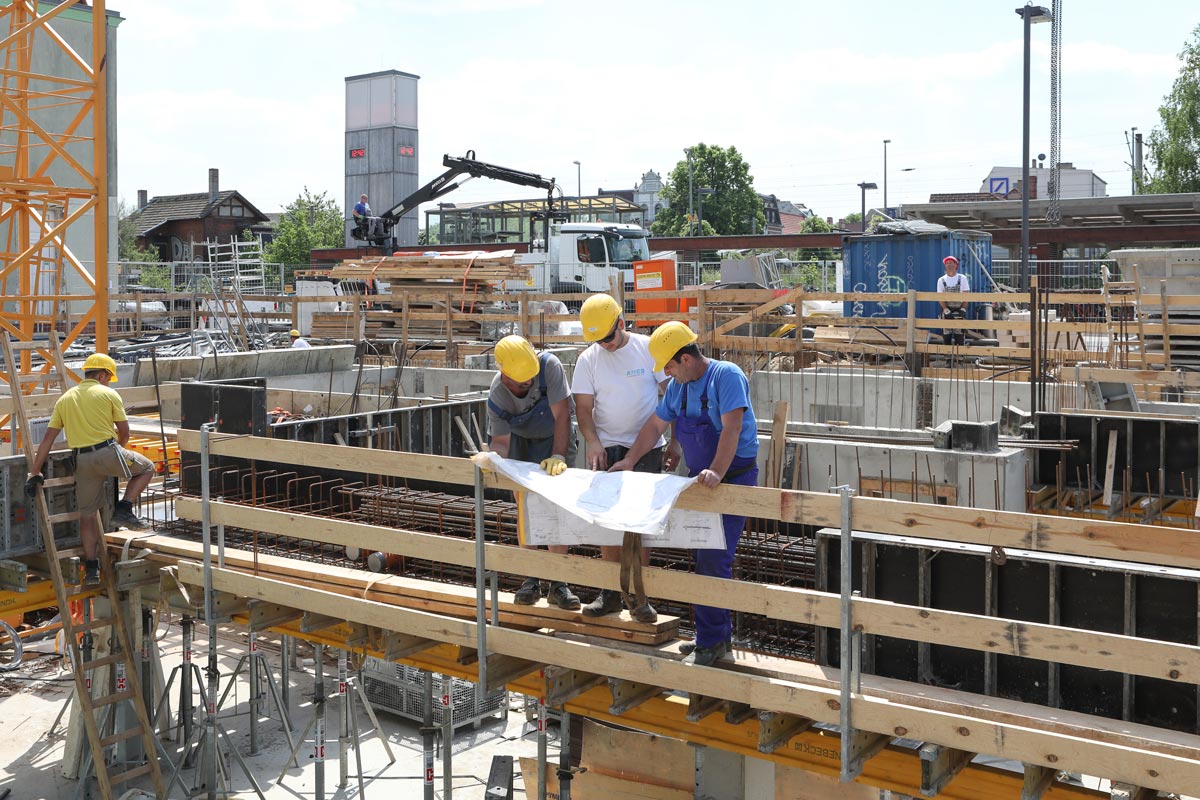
[106,531,679,645]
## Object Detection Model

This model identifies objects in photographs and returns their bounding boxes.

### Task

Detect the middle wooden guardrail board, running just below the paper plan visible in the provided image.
[164,498,1200,682]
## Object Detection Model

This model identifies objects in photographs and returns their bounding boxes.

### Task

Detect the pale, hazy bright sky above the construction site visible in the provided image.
[108,0,1200,225]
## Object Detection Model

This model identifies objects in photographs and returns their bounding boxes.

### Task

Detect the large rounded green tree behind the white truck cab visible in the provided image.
[650,142,767,236]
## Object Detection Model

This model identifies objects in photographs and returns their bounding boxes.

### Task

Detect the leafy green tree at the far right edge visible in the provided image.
[1145,25,1200,194]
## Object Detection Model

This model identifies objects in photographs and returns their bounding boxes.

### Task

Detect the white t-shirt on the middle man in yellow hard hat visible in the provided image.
[571,333,666,447]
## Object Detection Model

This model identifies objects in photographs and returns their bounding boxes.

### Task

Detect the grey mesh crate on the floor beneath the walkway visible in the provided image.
[362,657,508,728]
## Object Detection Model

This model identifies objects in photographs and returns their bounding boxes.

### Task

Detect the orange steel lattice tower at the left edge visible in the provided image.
[0,0,110,381]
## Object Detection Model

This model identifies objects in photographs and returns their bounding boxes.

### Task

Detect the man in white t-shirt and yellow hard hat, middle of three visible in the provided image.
[571,294,666,622]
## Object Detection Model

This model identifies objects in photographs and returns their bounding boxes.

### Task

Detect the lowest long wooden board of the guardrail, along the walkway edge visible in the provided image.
[179,563,1200,792]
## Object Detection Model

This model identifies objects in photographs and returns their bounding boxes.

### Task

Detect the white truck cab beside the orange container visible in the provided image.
[508,222,650,294]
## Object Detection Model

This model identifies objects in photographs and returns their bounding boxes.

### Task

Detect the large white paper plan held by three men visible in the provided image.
[474,452,725,549]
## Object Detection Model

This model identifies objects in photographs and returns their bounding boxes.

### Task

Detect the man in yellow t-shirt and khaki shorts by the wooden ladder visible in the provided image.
[25,353,154,584]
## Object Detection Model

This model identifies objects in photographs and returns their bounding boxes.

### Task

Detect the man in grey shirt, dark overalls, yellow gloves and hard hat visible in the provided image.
[487,336,580,610]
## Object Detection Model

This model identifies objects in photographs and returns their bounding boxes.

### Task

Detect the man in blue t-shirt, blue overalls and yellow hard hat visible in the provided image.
[610,321,758,667]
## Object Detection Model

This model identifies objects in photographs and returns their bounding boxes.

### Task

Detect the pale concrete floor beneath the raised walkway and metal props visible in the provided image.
[0,615,558,800]
